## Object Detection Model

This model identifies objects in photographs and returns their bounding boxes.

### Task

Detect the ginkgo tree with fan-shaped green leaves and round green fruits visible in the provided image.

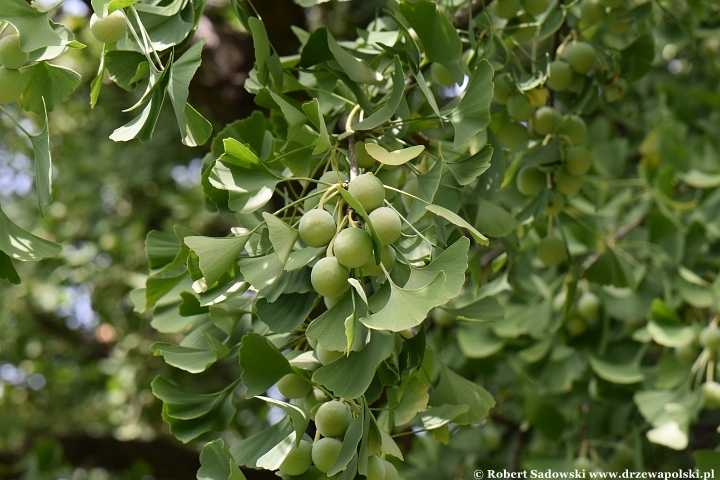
[0,0,720,480]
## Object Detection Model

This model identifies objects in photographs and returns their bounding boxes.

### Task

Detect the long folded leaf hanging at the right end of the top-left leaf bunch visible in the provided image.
[167,39,212,147]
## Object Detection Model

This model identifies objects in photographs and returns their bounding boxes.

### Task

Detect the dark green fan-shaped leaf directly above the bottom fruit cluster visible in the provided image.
[312,332,394,398]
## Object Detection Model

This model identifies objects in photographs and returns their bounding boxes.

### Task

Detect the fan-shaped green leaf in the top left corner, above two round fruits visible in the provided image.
[0,0,62,52]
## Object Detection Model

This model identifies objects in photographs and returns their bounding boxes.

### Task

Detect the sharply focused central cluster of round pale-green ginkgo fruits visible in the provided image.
[298,170,402,303]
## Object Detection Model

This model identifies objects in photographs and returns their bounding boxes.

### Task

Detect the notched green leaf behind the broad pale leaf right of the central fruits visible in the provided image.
[404,237,470,306]
